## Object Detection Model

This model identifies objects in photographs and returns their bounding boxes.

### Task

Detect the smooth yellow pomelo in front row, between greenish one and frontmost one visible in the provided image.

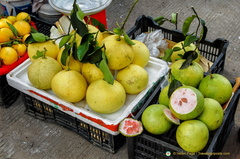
[51,70,87,103]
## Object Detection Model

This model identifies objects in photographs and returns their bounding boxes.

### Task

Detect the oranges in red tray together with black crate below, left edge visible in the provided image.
[0,12,36,108]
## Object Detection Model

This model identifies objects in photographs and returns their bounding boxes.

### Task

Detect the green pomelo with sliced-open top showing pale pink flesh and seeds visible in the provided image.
[169,86,204,120]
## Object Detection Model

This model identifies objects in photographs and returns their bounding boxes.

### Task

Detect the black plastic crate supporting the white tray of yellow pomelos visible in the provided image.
[21,92,126,153]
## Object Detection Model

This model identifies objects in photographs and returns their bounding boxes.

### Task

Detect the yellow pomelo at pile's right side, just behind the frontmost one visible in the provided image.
[116,64,148,94]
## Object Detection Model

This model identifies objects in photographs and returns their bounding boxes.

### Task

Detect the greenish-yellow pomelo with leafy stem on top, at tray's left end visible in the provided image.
[27,56,62,90]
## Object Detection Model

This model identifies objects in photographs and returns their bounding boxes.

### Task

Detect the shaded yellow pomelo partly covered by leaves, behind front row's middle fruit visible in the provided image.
[57,48,83,72]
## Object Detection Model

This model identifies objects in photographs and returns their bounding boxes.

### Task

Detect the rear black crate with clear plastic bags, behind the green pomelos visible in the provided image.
[127,15,229,73]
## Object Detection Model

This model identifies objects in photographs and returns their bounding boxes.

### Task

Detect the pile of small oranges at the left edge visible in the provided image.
[0,12,31,65]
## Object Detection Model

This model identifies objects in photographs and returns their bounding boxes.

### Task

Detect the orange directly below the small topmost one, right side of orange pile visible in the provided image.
[13,20,31,36]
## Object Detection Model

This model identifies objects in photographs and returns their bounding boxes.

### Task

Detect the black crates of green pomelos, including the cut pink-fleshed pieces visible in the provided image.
[124,16,240,159]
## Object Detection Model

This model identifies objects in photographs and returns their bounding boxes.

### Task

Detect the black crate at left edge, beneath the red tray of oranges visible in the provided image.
[0,75,19,108]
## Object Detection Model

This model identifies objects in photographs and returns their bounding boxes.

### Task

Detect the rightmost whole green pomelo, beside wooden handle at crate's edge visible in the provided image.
[198,74,232,104]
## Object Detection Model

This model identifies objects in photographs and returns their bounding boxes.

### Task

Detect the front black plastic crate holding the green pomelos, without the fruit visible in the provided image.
[127,80,240,159]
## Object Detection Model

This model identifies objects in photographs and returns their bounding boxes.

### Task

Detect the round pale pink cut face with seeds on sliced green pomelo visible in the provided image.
[171,88,197,114]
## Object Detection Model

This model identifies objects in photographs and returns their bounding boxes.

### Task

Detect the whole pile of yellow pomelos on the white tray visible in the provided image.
[27,20,150,114]
